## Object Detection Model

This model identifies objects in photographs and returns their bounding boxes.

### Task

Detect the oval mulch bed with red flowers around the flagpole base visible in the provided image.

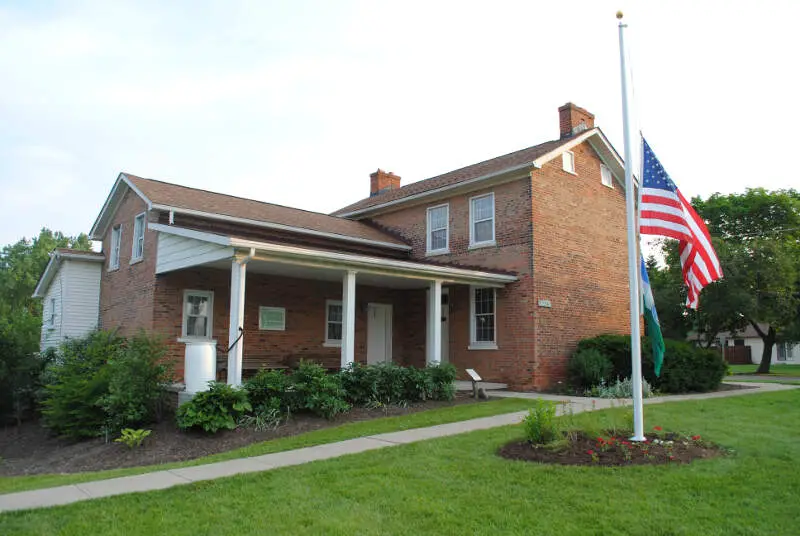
[498,432,725,467]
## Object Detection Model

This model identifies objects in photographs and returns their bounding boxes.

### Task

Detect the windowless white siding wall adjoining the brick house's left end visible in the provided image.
[59,259,103,338]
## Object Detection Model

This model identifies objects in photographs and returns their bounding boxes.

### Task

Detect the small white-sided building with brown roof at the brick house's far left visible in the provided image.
[33,248,104,351]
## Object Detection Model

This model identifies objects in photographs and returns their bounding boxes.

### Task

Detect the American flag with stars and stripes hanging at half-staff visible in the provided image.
[639,138,722,309]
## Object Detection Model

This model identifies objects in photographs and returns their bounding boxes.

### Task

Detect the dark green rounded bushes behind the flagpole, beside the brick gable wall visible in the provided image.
[578,335,726,393]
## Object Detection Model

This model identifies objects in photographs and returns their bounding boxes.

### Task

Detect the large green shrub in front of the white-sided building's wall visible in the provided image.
[42,331,124,439]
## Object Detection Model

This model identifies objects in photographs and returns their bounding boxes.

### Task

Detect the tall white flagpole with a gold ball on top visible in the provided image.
[617,11,645,441]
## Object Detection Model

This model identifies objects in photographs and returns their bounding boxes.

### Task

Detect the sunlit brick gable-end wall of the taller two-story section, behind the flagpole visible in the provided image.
[531,143,630,388]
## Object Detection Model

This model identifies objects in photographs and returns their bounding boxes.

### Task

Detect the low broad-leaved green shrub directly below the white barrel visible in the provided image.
[177,382,253,434]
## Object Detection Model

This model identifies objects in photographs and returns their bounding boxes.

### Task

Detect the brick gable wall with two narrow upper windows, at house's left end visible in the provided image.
[100,190,157,335]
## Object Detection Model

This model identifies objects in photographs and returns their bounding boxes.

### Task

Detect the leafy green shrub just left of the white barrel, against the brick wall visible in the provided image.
[100,332,172,432]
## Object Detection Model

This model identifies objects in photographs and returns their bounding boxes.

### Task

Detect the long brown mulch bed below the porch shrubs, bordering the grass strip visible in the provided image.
[0,393,484,476]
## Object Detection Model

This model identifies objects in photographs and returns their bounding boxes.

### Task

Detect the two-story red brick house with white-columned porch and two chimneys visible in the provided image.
[81,103,629,393]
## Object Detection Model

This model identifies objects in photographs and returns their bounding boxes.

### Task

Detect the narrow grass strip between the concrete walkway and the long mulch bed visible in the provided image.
[0,398,535,494]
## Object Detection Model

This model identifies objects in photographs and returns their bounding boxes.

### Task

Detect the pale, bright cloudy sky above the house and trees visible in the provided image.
[0,0,800,245]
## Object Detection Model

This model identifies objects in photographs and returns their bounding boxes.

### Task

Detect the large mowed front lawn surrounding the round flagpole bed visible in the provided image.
[0,390,800,536]
